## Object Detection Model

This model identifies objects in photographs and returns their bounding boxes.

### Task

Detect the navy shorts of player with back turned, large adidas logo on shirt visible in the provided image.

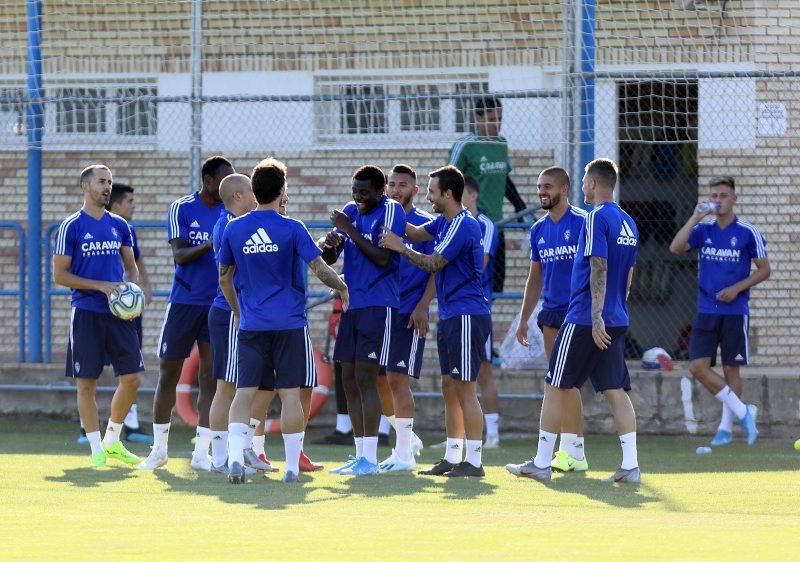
[236,326,317,390]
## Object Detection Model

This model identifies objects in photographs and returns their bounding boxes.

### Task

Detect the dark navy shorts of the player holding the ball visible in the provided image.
[66,308,144,379]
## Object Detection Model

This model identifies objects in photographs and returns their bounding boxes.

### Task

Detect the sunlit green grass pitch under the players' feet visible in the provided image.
[0,421,800,562]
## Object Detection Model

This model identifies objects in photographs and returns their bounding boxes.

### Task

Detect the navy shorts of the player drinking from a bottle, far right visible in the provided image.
[689,313,750,365]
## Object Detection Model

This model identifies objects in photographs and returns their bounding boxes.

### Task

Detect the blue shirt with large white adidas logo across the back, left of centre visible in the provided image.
[219,210,322,331]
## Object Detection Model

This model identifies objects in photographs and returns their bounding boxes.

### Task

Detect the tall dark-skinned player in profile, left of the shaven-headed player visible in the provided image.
[139,156,230,470]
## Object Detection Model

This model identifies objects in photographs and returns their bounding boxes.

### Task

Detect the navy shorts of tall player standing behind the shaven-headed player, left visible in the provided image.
[158,302,211,360]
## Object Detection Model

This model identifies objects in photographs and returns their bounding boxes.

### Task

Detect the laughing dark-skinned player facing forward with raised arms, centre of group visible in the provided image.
[318,166,406,476]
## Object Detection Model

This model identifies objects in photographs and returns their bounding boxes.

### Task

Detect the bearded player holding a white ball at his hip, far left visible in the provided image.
[53,165,144,466]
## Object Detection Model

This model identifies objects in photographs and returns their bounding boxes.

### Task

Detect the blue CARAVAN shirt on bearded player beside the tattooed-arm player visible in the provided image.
[531,205,587,310]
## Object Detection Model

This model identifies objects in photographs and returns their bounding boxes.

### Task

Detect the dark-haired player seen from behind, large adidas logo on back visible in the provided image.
[219,158,349,484]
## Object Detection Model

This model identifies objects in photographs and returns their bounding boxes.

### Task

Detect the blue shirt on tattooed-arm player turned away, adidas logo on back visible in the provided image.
[565,201,639,327]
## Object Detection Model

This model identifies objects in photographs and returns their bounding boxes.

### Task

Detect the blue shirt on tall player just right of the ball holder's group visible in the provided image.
[167,192,224,306]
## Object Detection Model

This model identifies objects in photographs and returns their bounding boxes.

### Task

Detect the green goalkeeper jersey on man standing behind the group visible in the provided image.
[449,133,511,222]
